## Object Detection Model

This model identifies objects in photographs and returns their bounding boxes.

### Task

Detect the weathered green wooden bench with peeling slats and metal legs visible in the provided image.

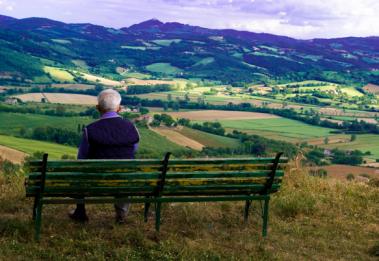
[25,153,287,240]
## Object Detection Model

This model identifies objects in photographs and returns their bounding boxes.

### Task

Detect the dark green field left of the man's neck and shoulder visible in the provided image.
[0,112,93,135]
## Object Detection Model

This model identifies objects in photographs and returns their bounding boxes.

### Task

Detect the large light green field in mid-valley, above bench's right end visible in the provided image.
[220,118,332,138]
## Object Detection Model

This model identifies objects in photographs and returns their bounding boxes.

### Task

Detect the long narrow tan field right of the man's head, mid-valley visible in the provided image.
[167,110,280,121]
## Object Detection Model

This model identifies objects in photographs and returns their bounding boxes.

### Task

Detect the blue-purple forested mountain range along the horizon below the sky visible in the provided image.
[0,16,379,85]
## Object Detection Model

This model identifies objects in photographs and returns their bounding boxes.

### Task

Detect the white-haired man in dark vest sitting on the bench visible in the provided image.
[69,89,139,223]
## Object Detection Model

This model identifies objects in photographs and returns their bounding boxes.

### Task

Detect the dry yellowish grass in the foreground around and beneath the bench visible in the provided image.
[0,164,379,256]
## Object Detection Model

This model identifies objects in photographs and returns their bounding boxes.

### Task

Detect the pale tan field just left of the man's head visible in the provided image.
[15,93,97,105]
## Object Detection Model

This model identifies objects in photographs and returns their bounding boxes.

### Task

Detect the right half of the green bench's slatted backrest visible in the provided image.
[162,154,287,195]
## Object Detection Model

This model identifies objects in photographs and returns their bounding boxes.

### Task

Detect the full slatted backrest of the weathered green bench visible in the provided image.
[26,154,287,197]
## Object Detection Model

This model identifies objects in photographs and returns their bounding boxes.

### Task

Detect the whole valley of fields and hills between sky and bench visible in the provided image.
[0,14,379,181]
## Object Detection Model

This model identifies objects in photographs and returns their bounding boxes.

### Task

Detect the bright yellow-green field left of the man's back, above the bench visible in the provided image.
[0,135,78,159]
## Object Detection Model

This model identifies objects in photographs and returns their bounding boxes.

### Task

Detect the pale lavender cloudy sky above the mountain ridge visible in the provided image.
[0,0,379,39]
